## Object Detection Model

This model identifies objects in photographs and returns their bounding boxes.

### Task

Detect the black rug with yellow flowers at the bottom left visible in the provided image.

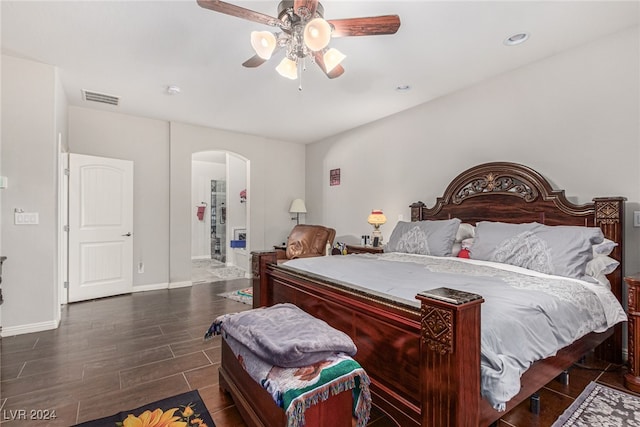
[76,390,215,427]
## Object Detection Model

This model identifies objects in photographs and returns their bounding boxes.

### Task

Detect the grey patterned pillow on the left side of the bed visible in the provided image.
[385,218,460,256]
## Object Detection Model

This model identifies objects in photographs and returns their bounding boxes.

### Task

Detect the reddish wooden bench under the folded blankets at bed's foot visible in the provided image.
[219,339,353,427]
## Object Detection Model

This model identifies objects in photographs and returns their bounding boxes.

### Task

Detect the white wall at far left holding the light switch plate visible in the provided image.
[0,55,66,336]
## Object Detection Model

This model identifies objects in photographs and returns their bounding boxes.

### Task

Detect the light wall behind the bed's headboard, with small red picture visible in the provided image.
[306,27,640,274]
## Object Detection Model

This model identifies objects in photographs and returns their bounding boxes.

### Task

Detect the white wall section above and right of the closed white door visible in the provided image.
[69,107,171,290]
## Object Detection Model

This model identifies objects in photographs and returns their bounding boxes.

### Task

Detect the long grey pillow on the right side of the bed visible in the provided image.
[471,221,604,279]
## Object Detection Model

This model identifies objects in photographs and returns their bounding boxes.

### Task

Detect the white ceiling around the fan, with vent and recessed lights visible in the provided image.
[1,0,639,143]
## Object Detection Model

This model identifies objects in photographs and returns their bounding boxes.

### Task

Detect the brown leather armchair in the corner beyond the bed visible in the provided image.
[276,224,336,262]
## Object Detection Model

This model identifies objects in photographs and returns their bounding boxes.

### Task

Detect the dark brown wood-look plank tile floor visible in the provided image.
[0,279,624,427]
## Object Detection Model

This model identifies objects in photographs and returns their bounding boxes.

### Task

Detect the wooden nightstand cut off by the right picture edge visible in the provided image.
[624,273,640,393]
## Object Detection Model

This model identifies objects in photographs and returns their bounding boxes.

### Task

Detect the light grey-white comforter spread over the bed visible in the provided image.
[284,253,627,410]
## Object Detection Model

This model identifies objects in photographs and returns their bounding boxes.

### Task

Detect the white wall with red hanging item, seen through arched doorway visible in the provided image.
[191,160,227,259]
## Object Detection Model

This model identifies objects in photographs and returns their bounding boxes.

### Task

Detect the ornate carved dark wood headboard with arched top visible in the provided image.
[410,162,626,357]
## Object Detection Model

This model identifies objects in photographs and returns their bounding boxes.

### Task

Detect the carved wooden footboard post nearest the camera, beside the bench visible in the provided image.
[416,288,484,427]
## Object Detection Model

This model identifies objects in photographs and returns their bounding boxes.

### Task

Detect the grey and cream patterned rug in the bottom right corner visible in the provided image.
[552,382,640,427]
